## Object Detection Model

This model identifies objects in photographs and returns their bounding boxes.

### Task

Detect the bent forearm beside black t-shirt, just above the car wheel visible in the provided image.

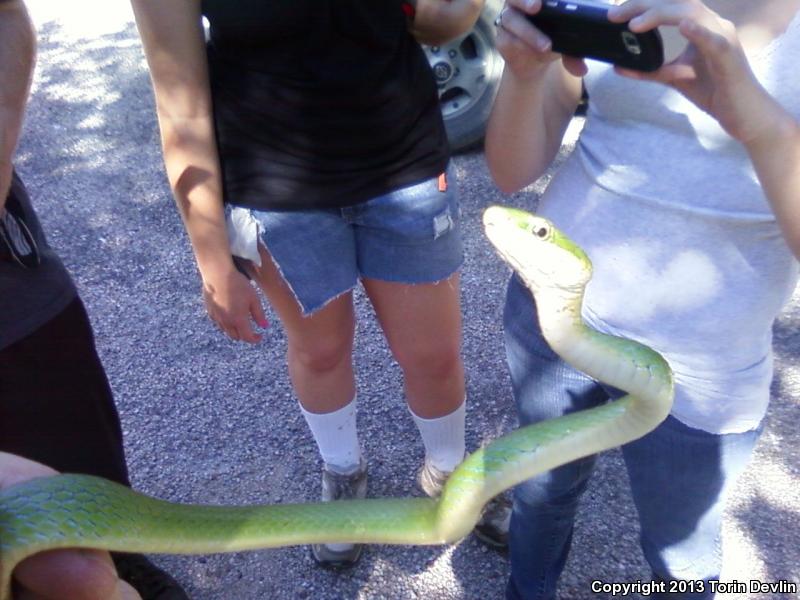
[409,0,485,46]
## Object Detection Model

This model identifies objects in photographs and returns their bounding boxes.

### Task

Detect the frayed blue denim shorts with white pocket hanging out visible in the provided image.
[226,165,464,314]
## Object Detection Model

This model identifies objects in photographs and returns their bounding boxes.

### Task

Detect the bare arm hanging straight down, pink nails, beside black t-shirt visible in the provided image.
[132,0,266,343]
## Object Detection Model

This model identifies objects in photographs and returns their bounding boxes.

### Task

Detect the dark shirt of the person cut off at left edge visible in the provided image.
[0,173,77,348]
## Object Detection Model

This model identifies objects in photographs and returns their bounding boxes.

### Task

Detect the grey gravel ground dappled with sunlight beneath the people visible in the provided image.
[17,0,800,600]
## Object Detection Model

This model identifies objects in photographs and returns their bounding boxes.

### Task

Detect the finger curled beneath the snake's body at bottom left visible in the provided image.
[14,550,121,600]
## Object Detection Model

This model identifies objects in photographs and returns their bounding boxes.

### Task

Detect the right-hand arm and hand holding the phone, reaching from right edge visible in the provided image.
[609,0,800,258]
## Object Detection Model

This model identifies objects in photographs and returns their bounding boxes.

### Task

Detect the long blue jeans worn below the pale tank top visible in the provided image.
[504,276,761,600]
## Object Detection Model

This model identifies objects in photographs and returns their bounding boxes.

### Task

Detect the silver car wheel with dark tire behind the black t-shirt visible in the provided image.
[425,0,503,152]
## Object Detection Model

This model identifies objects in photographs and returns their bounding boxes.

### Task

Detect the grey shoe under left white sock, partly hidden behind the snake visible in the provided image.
[311,460,367,569]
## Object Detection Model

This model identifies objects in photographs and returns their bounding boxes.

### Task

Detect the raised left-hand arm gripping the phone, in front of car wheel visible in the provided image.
[485,0,585,193]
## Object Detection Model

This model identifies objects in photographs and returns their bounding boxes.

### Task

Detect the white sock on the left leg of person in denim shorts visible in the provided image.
[300,397,361,475]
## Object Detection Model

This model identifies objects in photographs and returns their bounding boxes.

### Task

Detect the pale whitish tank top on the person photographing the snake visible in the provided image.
[539,13,800,433]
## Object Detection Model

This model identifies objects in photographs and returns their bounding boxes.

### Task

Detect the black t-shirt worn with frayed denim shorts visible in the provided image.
[202,0,449,210]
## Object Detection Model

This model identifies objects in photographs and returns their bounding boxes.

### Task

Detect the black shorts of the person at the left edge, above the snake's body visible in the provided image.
[0,297,129,485]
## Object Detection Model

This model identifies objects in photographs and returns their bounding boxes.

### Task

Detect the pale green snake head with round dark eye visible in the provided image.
[483,206,592,293]
